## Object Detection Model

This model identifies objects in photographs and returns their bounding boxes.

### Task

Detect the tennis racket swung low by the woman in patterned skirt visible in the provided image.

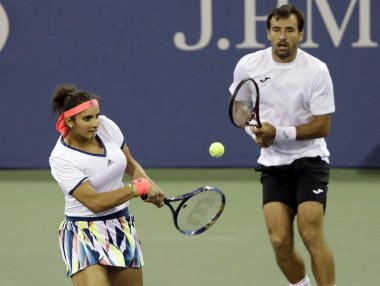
[164,186,226,235]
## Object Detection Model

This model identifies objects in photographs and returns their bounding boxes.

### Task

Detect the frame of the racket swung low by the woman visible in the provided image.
[164,186,226,235]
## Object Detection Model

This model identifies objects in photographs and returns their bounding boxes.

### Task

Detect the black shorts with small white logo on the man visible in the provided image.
[256,156,330,213]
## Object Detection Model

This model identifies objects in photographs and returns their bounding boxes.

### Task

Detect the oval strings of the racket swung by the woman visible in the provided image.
[177,190,224,231]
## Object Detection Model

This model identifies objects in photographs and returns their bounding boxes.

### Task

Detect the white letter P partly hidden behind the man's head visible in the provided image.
[236,0,288,49]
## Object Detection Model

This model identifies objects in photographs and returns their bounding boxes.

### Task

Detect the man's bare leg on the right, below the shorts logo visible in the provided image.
[297,202,335,286]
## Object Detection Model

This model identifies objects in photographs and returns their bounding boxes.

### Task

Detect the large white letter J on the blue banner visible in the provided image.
[174,0,212,51]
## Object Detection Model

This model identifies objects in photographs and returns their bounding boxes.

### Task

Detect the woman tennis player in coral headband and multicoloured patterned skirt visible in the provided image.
[49,85,164,286]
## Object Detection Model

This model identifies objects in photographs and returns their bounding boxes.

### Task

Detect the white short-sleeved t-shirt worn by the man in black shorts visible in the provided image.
[230,47,335,166]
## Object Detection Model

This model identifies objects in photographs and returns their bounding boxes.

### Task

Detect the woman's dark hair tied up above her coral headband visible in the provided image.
[51,84,99,114]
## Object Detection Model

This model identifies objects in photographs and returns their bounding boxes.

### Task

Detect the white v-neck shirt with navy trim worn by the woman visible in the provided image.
[49,115,128,217]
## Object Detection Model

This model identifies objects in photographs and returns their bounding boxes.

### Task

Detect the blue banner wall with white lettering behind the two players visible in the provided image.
[0,0,380,168]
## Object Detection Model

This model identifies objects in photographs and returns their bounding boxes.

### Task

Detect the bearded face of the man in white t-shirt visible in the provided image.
[267,15,303,63]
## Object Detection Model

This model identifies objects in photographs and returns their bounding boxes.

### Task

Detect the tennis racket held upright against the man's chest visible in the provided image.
[229,78,261,128]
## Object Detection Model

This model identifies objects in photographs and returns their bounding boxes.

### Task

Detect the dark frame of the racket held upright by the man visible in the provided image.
[229,77,262,128]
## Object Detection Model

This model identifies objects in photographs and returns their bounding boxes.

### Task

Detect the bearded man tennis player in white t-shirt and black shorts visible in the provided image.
[230,5,335,286]
